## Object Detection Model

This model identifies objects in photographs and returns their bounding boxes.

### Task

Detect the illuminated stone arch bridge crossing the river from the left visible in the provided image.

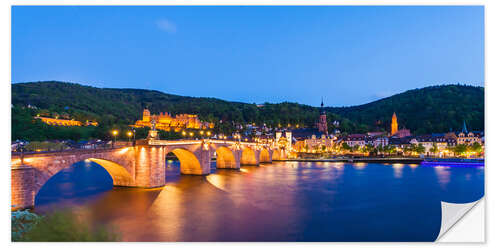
[11,139,273,209]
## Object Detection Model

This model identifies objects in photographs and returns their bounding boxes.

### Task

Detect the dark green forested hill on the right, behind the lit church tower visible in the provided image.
[327,85,484,134]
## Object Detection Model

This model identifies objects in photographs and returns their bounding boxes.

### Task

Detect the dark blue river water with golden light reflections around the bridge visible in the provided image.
[35,162,484,241]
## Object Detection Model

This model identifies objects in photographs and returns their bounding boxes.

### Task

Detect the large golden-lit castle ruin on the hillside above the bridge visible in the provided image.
[133,109,214,132]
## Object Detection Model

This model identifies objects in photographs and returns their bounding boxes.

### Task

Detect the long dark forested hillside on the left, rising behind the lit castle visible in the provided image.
[12,81,328,129]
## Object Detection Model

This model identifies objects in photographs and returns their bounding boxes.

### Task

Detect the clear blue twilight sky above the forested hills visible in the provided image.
[12,6,484,106]
